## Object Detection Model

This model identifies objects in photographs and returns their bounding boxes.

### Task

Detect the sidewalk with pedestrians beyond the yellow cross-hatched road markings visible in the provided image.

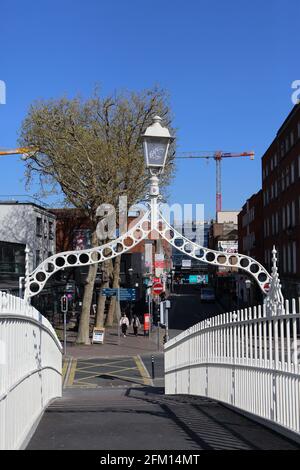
[62,326,165,359]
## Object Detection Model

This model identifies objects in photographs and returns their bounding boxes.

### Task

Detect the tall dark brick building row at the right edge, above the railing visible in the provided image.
[239,104,300,298]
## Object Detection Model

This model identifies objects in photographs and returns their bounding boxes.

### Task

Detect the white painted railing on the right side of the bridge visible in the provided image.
[165,300,300,434]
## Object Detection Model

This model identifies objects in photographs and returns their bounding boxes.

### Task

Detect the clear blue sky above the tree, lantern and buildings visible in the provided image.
[0,0,300,220]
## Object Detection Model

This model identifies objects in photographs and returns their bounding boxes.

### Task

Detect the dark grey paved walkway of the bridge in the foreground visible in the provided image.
[28,387,299,451]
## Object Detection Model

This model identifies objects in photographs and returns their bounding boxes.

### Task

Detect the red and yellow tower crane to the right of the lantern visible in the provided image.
[175,151,254,212]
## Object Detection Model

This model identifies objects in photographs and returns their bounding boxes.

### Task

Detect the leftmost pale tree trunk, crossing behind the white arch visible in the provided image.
[76,232,98,344]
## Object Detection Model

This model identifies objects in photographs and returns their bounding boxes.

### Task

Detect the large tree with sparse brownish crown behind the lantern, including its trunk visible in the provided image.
[20,87,174,344]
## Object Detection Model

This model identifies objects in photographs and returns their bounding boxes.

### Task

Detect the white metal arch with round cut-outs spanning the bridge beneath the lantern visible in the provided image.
[25,200,272,299]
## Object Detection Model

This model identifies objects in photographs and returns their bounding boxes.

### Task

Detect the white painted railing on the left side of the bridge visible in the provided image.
[0,292,62,449]
